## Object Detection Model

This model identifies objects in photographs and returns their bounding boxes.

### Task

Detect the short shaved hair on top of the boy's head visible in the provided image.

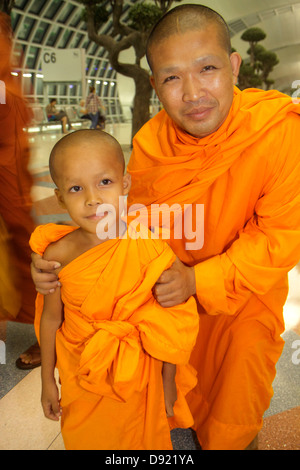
[49,129,125,184]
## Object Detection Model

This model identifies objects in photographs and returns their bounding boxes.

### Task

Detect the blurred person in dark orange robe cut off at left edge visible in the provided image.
[0,13,40,367]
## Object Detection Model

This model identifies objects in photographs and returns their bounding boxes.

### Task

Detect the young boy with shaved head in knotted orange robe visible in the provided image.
[30,130,198,450]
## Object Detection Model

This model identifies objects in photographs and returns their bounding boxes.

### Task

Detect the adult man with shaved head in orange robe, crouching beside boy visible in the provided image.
[33,5,300,450]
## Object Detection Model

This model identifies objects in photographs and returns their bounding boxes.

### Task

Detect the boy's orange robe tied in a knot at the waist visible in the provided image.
[31,224,199,450]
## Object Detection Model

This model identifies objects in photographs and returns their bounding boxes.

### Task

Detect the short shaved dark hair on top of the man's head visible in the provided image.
[146,4,231,70]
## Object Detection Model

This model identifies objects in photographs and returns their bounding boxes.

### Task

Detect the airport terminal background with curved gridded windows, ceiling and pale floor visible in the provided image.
[0,0,300,450]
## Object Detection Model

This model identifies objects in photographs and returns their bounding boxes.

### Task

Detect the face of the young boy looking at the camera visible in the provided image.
[55,142,130,234]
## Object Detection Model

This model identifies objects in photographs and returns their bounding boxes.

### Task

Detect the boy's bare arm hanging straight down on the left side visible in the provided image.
[40,289,63,421]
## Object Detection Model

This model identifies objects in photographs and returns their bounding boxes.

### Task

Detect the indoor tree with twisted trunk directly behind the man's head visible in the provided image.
[81,0,181,136]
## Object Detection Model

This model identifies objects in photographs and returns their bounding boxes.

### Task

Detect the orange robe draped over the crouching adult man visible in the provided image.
[128,88,300,449]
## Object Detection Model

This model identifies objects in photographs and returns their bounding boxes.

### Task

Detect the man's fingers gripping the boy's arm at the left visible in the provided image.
[31,253,60,295]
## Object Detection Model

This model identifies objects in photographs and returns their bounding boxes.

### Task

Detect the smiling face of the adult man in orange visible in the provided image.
[151,25,241,138]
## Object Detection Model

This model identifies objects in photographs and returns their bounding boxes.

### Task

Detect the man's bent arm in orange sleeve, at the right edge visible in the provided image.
[195,151,300,315]
